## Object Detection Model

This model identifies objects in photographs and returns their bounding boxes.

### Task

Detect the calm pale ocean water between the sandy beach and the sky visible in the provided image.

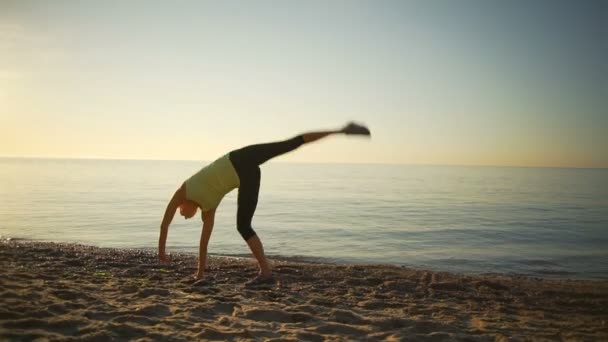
[0,158,608,279]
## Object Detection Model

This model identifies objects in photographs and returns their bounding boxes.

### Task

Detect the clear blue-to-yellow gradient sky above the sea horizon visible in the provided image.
[0,0,608,167]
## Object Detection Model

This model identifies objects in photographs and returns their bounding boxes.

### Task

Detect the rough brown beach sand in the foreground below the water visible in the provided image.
[0,240,608,341]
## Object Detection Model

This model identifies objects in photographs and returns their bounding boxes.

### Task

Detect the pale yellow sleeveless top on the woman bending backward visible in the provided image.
[185,154,240,211]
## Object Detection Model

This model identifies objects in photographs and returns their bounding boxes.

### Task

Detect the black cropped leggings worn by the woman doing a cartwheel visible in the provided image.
[228,135,304,241]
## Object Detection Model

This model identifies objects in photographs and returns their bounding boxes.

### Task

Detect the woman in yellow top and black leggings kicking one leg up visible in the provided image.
[158,123,370,284]
